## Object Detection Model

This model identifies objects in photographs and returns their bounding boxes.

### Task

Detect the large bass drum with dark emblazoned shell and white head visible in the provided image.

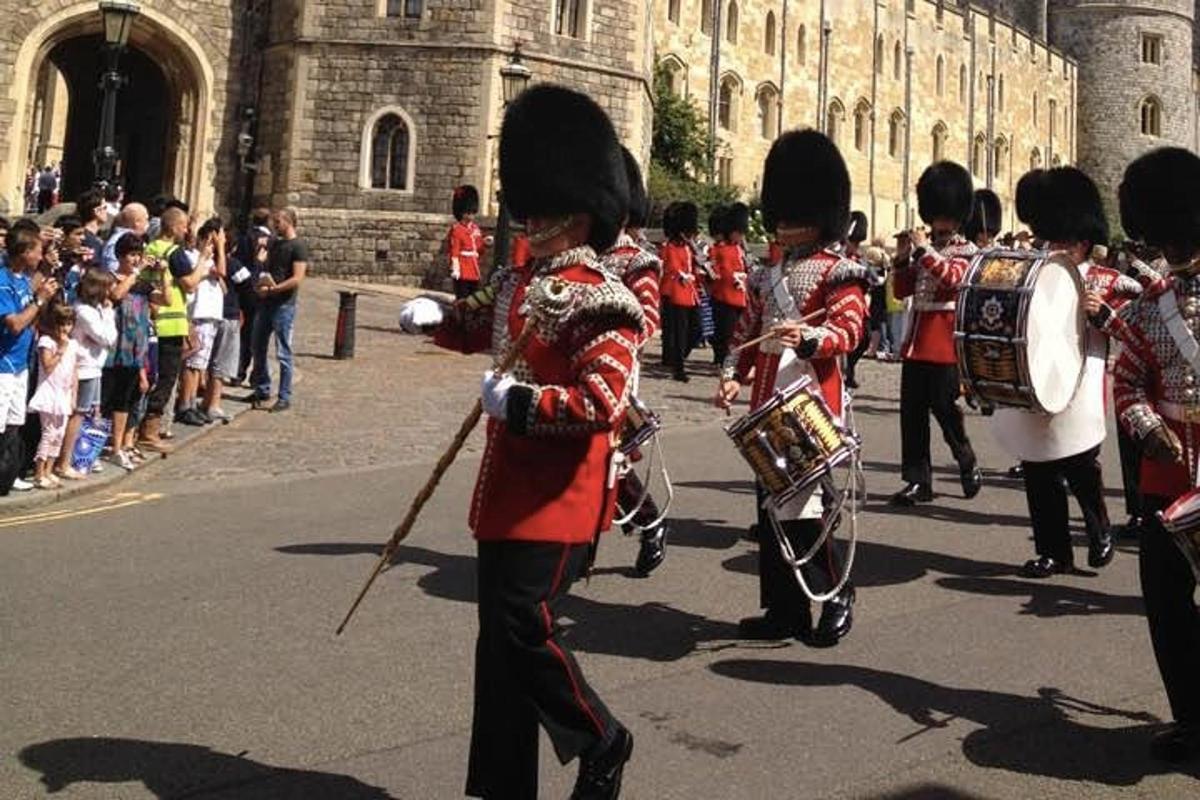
[954,249,1087,414]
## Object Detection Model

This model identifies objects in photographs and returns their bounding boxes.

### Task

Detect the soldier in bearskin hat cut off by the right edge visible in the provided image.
[1112,148,1200,763]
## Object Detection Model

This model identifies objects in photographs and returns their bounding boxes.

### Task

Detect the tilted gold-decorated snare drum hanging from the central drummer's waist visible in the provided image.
[725,377,860,509]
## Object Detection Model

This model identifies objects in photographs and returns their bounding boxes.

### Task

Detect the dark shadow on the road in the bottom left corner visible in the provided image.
[18,736,395,800]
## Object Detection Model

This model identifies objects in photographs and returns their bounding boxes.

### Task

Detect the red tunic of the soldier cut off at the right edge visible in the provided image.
[1112,276,1200,500]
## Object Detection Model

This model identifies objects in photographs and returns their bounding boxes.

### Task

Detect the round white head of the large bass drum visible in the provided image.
[1025,260,1085,414]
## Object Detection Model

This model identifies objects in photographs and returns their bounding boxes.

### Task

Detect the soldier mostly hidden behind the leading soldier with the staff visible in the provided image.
[601,148,670,577]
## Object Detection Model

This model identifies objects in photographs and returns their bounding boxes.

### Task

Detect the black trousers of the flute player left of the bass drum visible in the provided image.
[900,361,976,486]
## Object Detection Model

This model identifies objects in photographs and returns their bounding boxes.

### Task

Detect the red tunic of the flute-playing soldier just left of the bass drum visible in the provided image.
[893,236,978,363]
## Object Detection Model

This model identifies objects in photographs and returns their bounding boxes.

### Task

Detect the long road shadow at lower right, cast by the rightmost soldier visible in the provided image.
[709,660,1185,786]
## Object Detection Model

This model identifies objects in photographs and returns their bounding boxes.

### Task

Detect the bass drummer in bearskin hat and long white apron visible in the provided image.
[994,167,1141,578]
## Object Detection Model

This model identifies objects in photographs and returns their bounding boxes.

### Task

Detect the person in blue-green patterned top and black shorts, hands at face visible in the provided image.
[101,235,161,470]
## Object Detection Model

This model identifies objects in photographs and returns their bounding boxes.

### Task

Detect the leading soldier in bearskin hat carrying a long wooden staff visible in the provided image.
[436,85,643,800]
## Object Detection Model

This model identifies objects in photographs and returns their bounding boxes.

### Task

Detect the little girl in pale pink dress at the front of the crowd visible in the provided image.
[29,302,79,489]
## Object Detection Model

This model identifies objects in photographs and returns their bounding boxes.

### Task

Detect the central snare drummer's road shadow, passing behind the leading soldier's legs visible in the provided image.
[276,542,753,662]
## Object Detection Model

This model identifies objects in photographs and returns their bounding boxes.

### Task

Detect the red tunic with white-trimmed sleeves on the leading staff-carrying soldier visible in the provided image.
[434,247,642,545]
